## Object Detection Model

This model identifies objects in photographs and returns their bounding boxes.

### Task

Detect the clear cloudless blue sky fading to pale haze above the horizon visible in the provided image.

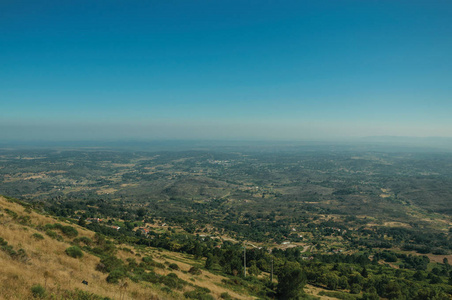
[0,0,452,140]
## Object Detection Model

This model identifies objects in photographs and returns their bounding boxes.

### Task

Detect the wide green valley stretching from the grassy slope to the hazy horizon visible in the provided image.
[0,142,452,299]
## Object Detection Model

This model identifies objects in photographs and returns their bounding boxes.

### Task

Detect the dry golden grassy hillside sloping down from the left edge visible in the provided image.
[0,197,262,299]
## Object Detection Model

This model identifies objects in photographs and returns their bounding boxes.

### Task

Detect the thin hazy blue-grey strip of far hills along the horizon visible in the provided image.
[0,136,452,152]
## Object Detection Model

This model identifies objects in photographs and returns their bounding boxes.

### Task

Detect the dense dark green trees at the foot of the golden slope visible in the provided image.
[75,218,452,299]
